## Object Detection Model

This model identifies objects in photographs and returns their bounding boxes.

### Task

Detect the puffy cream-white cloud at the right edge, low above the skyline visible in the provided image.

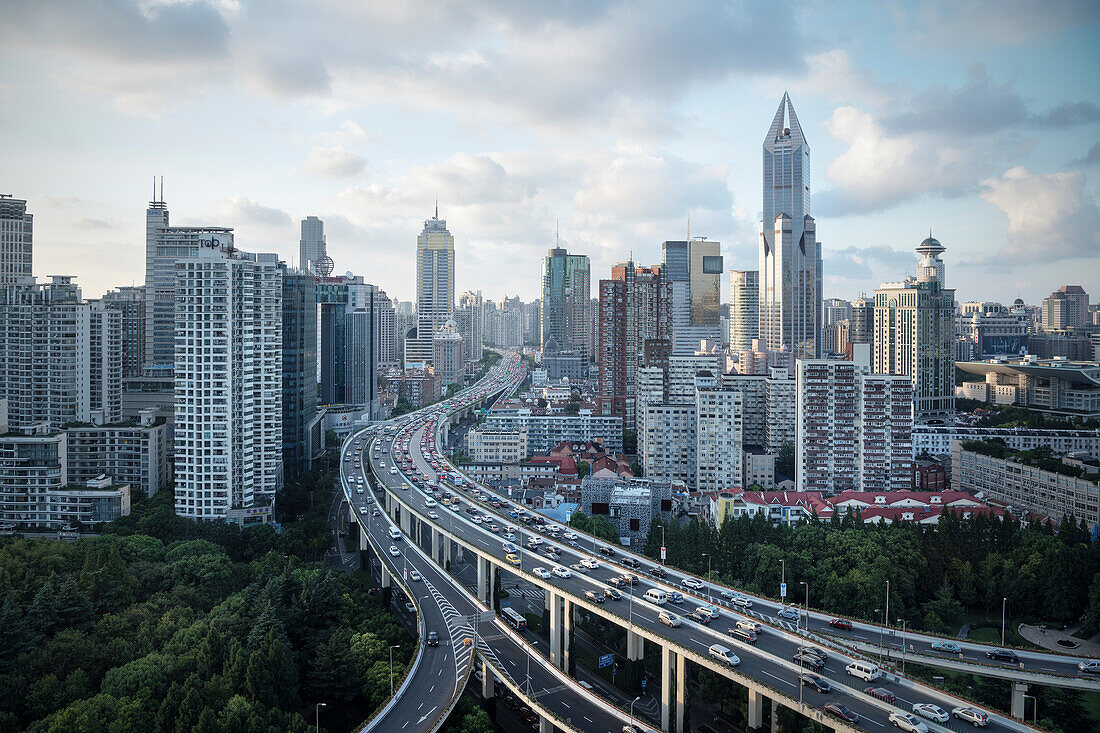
[974,166,1100,264]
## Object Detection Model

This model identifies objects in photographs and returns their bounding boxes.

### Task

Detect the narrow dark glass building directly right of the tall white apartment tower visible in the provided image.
[279,264,320,475]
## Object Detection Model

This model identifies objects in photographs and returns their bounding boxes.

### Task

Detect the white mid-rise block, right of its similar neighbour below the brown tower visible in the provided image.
[695,385,744,491]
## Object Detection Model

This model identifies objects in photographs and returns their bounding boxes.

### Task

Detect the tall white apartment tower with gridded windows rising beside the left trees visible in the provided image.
[174,242,283,524]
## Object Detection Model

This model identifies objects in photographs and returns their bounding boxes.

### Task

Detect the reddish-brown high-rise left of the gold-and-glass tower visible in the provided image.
[596,261,672,422]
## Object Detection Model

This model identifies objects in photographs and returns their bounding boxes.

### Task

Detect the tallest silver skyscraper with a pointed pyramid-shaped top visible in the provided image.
[760,92,822,359]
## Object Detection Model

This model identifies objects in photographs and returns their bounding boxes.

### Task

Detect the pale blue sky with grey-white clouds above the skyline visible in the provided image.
[0,0,1100,303]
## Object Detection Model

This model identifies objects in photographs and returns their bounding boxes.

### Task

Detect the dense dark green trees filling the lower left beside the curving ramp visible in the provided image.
[0,453,416,733]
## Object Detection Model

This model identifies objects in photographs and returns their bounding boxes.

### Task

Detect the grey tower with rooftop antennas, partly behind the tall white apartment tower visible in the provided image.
[145,196,233,375]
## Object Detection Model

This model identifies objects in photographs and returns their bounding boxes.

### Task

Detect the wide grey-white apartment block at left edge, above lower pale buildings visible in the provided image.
[0,275,122,429]
